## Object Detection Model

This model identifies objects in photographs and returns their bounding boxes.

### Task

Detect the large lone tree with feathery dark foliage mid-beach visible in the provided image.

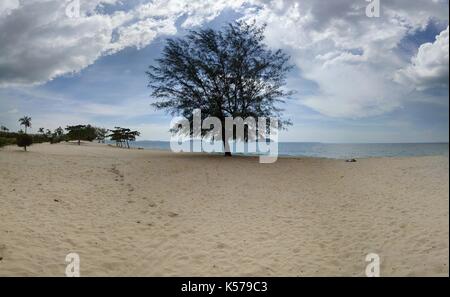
[147,22,292,155]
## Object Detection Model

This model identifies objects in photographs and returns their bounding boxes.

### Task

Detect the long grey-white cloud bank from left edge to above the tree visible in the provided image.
[0,0,246,87]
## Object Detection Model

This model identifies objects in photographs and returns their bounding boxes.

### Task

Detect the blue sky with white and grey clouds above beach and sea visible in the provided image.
[0,0,449,142]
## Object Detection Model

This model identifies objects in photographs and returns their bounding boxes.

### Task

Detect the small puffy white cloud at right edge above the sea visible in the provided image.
[395,27,449,90]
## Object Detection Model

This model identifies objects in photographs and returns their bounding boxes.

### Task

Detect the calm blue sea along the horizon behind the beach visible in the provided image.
[128,140,449,159]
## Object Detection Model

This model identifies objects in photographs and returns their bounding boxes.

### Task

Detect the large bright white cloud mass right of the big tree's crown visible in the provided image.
[245,0,448,118]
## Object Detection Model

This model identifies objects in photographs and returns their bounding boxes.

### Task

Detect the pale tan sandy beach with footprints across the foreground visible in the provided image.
[0,144,449,276]
